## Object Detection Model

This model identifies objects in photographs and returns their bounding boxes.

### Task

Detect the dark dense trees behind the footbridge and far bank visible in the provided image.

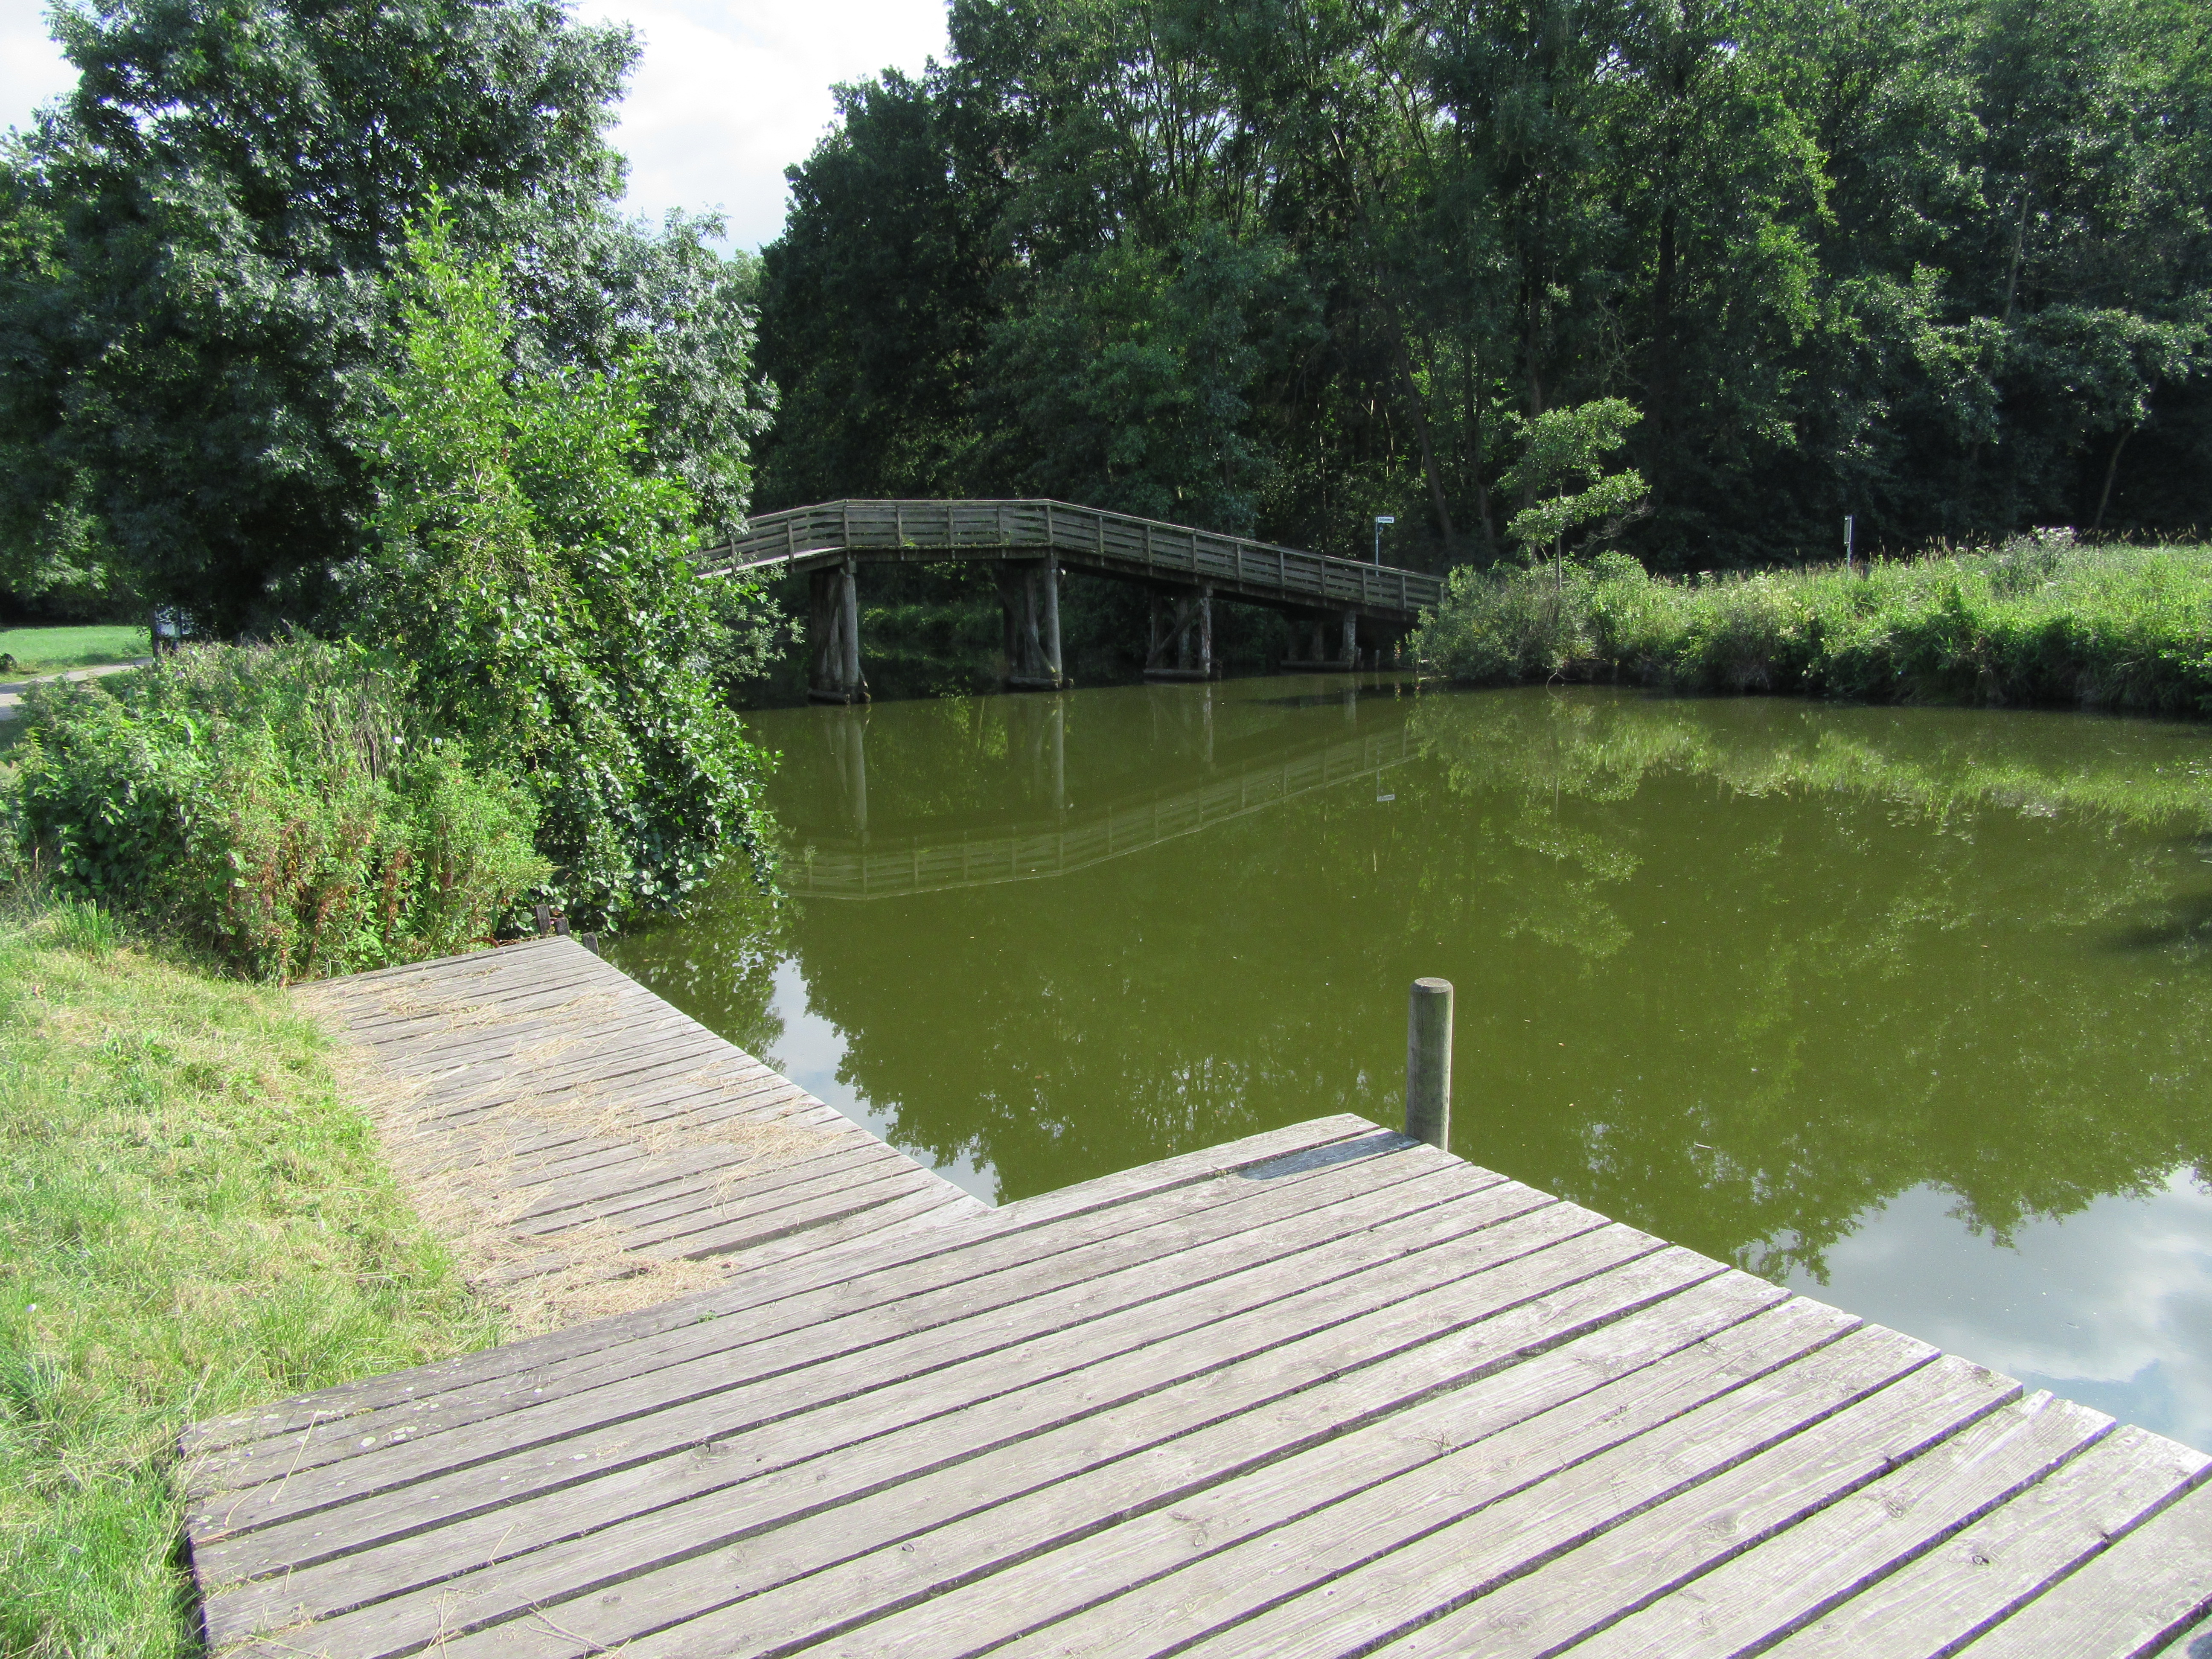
[761,0,2212,568]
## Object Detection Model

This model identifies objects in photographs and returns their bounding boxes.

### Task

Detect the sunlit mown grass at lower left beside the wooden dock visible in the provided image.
[0,900,500,1659]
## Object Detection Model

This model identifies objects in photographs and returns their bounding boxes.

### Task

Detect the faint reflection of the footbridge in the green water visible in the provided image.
[783,693,1420,898]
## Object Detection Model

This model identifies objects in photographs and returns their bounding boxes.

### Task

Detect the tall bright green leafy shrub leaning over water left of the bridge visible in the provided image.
[352,215,761,923]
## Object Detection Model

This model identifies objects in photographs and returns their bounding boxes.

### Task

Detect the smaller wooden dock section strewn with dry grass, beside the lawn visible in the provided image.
[294,938,987,1323]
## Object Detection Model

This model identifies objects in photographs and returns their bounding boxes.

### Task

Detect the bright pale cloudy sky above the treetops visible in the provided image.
[0,0,945,248]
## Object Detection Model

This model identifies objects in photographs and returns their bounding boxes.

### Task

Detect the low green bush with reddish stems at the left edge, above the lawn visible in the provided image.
[9,639,546,980]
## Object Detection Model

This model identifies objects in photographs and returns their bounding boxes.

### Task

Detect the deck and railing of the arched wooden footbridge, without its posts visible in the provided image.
[701,500,1444,624]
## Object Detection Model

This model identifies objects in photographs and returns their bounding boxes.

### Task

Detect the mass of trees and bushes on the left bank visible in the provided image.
[0,0,772,942]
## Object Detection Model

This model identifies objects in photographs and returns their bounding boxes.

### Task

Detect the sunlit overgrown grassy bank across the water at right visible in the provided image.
[1418,538,2212,714]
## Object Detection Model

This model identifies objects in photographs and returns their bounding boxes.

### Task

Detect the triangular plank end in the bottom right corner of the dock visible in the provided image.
[1960,1487,2212,1659]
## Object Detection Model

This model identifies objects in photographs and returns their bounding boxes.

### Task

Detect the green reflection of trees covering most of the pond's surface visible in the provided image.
[624,693,2212,1274]
